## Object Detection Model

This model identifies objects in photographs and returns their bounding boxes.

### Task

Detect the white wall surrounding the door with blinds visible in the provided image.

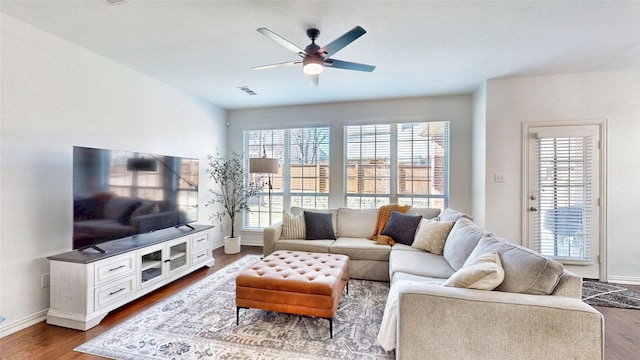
[484,69,640,283]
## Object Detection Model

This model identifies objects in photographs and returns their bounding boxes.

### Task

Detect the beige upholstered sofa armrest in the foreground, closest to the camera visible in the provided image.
[396,282,604,360]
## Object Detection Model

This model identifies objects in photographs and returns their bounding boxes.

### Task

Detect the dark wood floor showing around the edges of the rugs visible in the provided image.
[0,246,640,360]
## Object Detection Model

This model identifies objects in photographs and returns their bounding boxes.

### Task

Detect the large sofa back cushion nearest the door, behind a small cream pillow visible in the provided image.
[469,235,564,295]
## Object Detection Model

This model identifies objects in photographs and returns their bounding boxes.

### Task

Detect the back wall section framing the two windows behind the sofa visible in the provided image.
[229,95,472,219]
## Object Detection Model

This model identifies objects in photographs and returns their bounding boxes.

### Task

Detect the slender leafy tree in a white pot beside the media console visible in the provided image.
[206,152,258,254]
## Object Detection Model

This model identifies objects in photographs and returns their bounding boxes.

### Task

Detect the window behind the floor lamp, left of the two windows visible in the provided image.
[243,127,330,227]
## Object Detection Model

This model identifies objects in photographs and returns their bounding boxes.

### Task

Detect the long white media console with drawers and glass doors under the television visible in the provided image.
[47,225,215,330]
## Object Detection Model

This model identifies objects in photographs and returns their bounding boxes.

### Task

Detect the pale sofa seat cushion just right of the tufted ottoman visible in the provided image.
[389,249,455,279]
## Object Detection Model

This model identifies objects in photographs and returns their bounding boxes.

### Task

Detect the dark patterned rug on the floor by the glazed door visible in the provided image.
[582,280,640,310]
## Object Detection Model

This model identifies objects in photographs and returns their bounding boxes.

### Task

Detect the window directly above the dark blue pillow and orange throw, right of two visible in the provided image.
[344,121,449,208]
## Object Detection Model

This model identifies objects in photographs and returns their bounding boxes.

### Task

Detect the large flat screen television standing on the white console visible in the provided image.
[73,146,199,252]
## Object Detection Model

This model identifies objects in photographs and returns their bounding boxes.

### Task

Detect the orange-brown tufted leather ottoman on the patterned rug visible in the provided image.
[236,251,349,337]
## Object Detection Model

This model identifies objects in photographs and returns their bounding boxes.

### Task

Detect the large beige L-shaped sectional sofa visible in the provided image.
[264,208,604,360]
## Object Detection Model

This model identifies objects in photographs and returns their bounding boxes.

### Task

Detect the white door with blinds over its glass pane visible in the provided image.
[523,124,604,279]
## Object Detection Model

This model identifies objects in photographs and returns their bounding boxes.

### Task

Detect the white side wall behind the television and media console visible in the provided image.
[0,14,226,336]
